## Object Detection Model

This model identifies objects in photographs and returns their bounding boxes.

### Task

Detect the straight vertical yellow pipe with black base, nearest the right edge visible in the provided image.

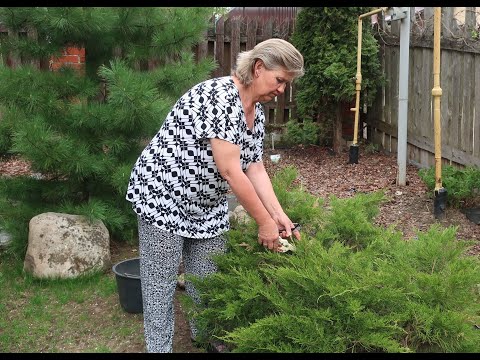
[432,7,447,218]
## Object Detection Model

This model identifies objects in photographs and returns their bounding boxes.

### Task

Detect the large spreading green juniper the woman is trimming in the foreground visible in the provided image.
[182,168,480,353]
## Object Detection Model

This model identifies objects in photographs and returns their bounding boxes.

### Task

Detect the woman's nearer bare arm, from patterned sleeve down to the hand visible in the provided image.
[210,138,279,251]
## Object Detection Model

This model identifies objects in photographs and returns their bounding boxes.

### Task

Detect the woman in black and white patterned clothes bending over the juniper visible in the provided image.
[126,39,304,352]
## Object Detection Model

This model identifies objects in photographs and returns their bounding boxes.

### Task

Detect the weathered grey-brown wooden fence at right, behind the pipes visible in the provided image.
[365,7,480,167]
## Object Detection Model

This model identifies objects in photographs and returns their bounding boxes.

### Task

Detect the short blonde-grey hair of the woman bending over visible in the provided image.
[232,39,304,85]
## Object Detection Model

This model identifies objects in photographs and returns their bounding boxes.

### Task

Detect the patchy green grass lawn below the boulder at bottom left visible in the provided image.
[0,257,145,353]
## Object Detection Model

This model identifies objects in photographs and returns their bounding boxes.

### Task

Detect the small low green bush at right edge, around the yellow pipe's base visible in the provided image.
[418,165,480,207]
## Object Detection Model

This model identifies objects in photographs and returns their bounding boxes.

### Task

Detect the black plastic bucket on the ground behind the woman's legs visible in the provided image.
[112,258,143,313]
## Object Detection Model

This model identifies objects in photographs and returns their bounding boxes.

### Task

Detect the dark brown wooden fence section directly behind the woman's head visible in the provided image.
[195,17,296,127]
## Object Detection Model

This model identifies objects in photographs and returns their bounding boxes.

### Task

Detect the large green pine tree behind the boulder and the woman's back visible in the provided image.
[0,7,215,255]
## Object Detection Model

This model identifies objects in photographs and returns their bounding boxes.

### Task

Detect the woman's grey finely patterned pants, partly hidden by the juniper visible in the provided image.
[138,218,226,353]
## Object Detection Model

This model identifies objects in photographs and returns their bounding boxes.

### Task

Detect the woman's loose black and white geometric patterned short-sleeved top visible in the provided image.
[126,76,265,239]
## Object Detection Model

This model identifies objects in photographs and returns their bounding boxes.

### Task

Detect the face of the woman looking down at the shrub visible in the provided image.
[254,62,293,102]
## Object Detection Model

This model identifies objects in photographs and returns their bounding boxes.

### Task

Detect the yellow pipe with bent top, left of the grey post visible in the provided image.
[349,7,388,164]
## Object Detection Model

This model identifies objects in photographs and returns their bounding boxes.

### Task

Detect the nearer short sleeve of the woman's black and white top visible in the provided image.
[193,82,240,145]
